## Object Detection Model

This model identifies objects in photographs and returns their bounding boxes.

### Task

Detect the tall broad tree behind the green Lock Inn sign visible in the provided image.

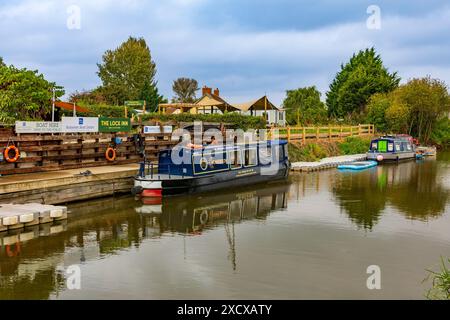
[97,37,156,104]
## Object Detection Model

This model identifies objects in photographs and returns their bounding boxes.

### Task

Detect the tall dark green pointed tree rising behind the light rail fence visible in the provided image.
[326,48,400,117]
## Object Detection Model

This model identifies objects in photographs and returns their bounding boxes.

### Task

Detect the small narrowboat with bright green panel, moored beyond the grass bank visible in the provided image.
[367,136,416,162]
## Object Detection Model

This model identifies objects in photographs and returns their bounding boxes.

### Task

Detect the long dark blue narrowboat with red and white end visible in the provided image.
[131,140,290,197]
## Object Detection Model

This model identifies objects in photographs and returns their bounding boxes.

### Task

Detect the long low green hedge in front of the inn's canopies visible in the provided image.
[142,112,266,130]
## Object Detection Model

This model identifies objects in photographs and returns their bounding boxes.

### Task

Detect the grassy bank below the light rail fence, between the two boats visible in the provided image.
[288,137,370,162]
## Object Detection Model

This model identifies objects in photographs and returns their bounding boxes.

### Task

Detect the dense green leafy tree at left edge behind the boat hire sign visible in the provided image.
[0,64,64,123]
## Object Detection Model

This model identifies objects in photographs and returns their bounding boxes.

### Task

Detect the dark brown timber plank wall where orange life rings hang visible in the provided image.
[0,128,175,175]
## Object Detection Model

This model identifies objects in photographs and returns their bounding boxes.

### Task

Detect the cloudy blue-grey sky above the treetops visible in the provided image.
[0,0,450,104]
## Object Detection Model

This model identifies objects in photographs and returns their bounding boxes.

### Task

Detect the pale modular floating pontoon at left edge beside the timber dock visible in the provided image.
[0,203,67,232]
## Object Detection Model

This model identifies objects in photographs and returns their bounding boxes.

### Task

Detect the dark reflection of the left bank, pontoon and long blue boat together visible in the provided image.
[0,184,288,300]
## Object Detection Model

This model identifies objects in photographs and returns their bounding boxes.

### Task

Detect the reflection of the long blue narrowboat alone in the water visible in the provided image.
[136,184,289,234]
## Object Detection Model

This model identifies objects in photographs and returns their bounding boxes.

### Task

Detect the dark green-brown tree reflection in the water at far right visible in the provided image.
[332,159,449,230]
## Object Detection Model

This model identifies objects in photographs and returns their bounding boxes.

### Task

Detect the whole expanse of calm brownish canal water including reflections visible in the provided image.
[0,153,450,299]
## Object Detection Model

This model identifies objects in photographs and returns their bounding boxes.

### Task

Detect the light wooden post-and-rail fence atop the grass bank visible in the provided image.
[269,124,375,144]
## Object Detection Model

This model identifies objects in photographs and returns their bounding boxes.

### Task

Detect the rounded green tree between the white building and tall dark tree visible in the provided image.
[283,86,327,126]
